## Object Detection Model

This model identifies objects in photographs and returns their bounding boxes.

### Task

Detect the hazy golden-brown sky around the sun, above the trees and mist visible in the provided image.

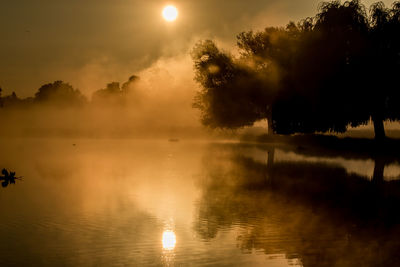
[0,0,392,97]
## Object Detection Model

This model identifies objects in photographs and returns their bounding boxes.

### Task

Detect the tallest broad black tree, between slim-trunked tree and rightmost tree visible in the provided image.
[274,1,370,133]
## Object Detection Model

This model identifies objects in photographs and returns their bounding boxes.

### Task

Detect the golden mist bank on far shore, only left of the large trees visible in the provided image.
[0,55,216,138]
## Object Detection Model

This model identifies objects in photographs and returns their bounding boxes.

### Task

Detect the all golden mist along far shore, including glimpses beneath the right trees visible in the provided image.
[0,49,399,139]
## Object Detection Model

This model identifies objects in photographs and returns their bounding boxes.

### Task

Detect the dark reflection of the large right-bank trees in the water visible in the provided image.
[194,147,400,266]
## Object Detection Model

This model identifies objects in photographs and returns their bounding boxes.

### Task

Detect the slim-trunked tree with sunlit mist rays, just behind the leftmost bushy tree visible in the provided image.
[237,25,300,133]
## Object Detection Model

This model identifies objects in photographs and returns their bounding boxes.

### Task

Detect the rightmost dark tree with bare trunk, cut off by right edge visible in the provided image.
[367,2,400,139]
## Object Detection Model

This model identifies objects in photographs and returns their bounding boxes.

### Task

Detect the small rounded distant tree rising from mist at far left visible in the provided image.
[34,81,87,107]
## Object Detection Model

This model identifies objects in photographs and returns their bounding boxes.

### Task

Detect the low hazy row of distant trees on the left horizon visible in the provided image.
[0,75,139,108]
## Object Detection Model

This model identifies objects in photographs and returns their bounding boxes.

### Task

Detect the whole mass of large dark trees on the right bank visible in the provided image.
[191,0,400,140]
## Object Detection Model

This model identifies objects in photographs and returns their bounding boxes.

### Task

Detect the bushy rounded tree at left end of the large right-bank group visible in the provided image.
[192,40,276,129]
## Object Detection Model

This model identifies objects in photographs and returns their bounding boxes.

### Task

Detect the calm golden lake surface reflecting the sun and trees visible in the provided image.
[0,139,400,266]
